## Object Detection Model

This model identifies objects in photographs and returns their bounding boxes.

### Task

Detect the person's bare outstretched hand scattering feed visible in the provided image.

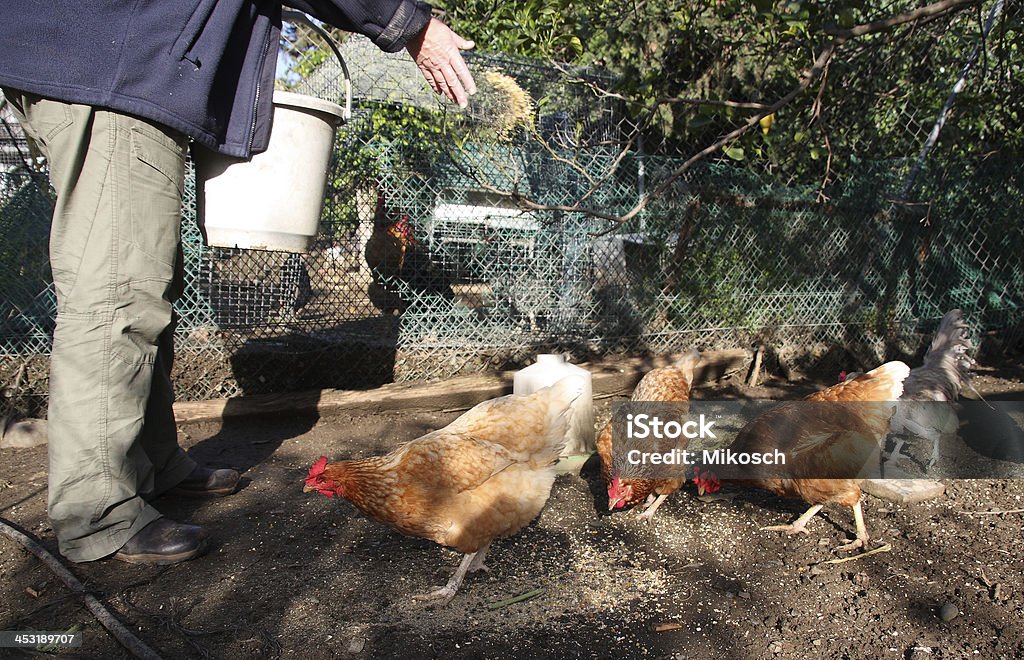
[406,17,476,107]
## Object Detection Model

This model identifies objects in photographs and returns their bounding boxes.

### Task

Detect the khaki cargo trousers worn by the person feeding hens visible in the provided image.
[4,90,195,562]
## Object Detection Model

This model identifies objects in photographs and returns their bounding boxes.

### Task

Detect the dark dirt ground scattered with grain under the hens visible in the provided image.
[0,367,1024,660]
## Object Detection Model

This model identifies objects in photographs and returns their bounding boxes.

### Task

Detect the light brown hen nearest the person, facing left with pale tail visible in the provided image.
[304,377,584,604]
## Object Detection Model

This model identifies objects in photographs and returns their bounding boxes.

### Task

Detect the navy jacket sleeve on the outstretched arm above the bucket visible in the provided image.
[284,0,431,52]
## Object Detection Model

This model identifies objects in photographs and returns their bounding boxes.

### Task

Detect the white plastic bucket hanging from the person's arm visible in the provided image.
[196,91,345,253]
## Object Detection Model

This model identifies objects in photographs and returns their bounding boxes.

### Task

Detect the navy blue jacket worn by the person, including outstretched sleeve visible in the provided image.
[0,0,430,158]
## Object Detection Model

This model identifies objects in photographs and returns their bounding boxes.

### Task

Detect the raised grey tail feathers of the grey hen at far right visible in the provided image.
[903,309,974,401]
